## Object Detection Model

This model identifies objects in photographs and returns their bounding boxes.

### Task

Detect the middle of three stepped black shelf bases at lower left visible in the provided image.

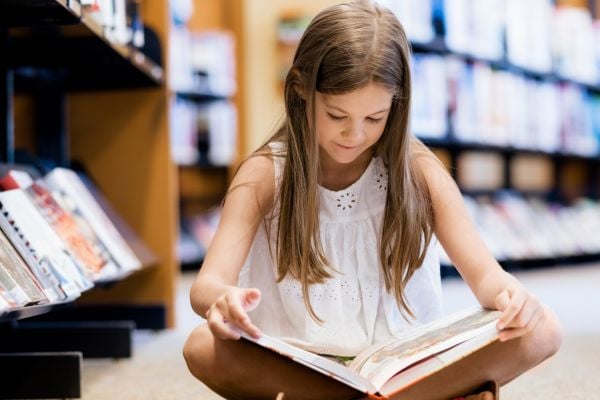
[0,321,135,360]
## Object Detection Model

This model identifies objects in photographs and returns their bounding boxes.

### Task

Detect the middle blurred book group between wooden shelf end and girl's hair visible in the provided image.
[170,96,237,166]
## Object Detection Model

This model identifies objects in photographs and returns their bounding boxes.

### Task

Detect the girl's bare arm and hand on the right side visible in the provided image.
[417,155,546,340]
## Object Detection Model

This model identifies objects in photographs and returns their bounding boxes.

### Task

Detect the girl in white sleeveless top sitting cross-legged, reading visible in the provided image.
[184,1,561,399]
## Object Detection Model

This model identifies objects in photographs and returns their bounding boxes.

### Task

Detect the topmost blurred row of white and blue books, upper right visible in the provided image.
[379,0,600,85]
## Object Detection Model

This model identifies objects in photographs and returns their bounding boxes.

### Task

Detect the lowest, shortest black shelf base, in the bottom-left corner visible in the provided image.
[0,352,81,399]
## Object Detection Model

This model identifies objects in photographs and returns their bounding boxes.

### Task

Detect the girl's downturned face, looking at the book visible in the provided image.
[315,83,392,164]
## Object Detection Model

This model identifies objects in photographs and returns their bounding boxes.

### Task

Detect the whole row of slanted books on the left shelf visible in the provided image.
[0,167,153,316]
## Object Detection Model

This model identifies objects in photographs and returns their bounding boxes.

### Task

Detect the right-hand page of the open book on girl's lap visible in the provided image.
[350,309,501,389]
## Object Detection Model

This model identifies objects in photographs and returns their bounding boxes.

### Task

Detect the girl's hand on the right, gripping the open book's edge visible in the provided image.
[496,283,546,342]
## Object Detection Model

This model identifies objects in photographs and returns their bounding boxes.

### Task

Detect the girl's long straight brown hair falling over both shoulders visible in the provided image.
[256,1,433,321]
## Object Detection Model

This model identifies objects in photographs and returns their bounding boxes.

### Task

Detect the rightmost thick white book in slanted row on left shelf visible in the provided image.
[44,168,142,273]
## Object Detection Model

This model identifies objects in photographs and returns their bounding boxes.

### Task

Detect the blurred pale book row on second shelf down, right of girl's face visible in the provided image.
[412,54,600,156]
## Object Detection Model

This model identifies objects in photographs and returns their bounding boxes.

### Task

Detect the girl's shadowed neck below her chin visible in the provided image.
[319,149,373,191]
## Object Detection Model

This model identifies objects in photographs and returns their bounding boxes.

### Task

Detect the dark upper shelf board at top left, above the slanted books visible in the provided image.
[0,0,164,91]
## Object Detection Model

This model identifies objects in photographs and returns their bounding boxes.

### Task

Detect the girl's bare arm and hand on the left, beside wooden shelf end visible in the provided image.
[190,156,275,339]
